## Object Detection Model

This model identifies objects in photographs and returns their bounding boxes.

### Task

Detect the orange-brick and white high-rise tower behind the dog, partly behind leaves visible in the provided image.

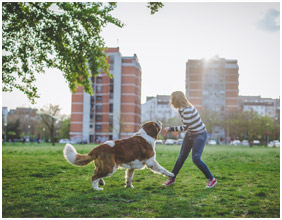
[70,48,141,143]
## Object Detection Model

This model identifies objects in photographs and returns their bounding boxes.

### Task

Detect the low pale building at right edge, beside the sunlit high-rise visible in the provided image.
[239,96,280,120]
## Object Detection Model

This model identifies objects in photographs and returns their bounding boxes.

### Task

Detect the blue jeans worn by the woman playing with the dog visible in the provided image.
[172,131,213,179]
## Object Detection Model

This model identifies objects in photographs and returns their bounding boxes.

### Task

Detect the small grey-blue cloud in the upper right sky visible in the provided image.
[257,8,280,32]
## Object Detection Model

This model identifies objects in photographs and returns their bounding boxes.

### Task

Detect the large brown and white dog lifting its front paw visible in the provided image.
[64,121,174,190]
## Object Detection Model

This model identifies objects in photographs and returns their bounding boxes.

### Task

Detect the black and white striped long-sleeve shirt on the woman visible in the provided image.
[169,106,206,133]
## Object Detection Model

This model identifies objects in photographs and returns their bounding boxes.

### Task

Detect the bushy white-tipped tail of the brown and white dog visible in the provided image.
[64,144,94,166]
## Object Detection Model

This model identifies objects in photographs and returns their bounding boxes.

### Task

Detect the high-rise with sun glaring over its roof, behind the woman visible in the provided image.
[186,56,239,113]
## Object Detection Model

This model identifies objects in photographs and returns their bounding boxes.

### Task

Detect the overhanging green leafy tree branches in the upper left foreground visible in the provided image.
[2,2,163,103]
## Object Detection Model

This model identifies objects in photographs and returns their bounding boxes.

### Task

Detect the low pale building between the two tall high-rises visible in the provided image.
[141,95,178,123]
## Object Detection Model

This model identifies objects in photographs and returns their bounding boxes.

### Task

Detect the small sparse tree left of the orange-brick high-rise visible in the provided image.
[39,105,60,146]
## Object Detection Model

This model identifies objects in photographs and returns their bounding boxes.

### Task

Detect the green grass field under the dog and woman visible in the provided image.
[2,144,280,218]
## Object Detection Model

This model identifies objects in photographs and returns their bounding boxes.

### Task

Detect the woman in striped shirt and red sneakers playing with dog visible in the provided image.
[162,91,217,188]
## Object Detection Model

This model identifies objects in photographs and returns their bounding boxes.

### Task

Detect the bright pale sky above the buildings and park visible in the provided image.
[2,2,280,114]
